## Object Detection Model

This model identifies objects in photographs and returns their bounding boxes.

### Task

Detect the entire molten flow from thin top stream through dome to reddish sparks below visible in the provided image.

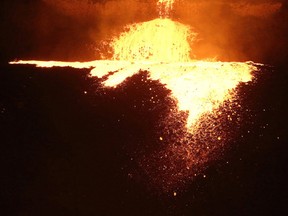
[10,0,257,192]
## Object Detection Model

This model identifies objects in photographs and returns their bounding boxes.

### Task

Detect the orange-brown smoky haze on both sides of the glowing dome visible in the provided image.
[0,0,288,64]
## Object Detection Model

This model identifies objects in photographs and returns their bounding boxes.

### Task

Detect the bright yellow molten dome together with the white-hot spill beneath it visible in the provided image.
[11,18,256,129]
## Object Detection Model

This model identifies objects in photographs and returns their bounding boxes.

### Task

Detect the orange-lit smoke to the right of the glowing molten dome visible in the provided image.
[175,1,287,63]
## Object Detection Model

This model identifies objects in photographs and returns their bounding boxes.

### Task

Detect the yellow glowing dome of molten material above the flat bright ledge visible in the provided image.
[112,19,195,62]
